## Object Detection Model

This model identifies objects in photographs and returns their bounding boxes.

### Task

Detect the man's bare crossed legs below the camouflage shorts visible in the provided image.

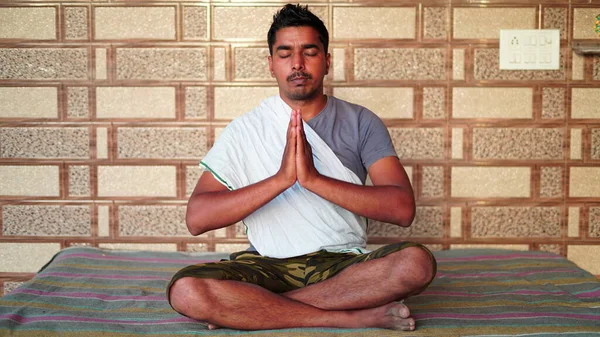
[169,243,435,330]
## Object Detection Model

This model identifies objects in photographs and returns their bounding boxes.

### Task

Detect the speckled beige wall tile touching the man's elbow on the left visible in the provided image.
[118,205,190,237]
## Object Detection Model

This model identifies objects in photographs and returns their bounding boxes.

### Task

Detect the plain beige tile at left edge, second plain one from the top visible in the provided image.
[0,87,58,118]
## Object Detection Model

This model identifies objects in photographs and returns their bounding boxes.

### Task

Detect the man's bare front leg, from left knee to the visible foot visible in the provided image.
[171,277,414,330]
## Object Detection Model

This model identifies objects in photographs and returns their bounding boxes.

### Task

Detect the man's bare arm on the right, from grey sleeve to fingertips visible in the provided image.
[296,111,415,227]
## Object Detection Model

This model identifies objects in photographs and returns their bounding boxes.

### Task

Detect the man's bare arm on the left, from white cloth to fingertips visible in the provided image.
[186,112,296,235]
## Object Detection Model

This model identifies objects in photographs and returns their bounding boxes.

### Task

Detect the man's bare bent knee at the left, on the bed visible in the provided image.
[169,277,210,320]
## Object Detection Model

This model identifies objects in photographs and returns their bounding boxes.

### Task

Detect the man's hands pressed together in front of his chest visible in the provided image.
[276,109,320,190]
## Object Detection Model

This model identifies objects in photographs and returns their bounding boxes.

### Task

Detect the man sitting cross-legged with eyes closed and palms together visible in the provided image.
[168,5,435,330]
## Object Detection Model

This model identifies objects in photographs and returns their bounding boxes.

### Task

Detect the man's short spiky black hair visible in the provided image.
[267,4,329,55]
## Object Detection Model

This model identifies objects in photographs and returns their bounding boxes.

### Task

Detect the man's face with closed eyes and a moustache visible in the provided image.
[269,27,330,101]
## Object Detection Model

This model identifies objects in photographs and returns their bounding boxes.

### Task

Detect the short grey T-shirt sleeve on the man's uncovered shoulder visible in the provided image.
[358,109,398,170]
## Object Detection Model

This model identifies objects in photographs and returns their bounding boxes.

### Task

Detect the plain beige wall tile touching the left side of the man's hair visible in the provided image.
[212,6,280,41]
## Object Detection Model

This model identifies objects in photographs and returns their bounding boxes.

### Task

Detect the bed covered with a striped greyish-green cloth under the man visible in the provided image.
[0,247,600,337]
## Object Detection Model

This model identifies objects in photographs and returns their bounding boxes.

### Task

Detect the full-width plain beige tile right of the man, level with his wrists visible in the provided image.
[451,166,531,198]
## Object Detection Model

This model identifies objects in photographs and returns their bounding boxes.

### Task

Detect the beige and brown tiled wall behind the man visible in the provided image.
[0,0,600,291]
